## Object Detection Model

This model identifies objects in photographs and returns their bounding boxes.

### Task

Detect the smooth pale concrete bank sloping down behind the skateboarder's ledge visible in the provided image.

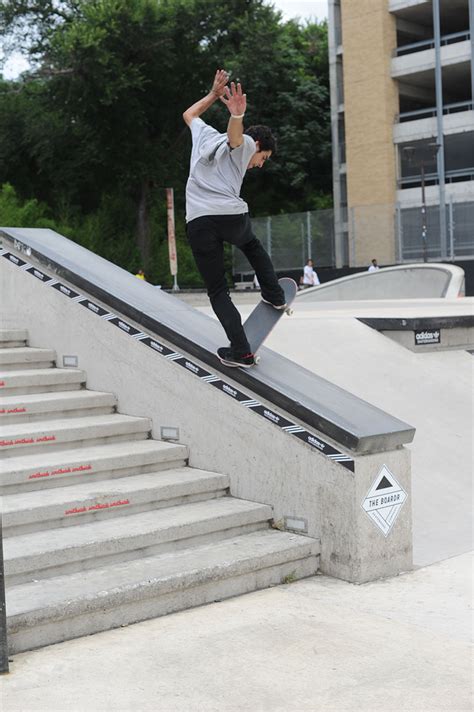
[246,299,474,565]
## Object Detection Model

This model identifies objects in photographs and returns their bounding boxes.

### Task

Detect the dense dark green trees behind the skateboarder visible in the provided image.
[0,0,330,282]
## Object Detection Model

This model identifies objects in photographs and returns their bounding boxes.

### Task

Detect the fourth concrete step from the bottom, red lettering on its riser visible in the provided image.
[1,440,188,494]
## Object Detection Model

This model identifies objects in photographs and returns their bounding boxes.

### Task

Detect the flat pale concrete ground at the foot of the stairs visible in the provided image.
[0,554,472,712]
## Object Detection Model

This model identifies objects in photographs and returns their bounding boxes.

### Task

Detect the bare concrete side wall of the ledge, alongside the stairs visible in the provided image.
[0,250,412,582]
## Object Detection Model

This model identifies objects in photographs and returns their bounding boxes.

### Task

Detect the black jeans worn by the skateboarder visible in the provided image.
[186,213,284,354]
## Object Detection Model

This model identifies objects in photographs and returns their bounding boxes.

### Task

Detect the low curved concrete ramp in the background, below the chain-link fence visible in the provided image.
[298,263,464,303]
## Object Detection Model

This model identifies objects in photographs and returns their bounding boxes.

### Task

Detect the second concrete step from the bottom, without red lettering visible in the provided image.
[3,498,266,583]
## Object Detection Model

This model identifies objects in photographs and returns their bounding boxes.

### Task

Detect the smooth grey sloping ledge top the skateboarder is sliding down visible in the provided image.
[0,228,414,453]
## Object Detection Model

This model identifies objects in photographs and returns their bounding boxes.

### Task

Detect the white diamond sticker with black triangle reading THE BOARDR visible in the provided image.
[361,465,408,537]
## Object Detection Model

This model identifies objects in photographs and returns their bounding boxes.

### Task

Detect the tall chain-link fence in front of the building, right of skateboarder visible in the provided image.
[233,201,474,279]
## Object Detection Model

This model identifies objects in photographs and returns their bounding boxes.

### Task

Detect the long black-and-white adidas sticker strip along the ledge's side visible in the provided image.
[0,247,354,472]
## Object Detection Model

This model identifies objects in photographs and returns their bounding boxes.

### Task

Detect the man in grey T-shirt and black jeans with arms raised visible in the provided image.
[183,69,286,368]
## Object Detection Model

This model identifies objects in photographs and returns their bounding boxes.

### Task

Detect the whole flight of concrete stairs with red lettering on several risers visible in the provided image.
[0,329,319,653]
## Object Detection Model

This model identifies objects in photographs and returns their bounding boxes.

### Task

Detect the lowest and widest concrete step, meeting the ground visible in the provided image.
[7,530,319,654]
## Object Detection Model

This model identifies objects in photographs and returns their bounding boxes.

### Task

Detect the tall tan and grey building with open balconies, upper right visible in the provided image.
[329,0,474,267]
